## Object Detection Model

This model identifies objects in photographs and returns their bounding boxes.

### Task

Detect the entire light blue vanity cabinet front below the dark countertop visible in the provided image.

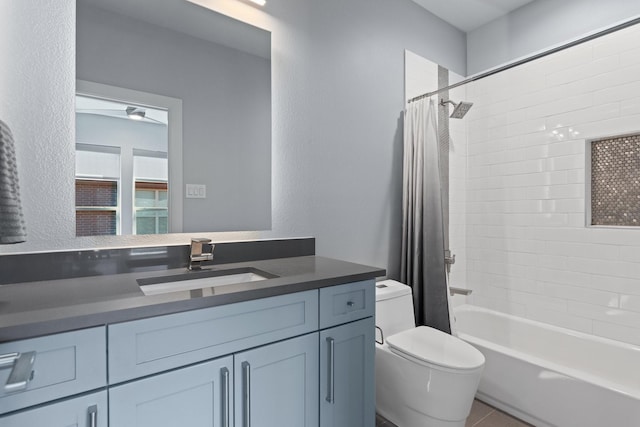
[0,280,375,427]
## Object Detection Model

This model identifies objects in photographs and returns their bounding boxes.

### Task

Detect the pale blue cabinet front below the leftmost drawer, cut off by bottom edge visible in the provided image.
[0,391,107,427]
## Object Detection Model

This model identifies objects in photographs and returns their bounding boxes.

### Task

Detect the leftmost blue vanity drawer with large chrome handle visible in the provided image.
[0,327,107,414]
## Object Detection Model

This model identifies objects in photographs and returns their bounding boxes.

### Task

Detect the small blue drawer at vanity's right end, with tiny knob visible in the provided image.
[320,280,376,329]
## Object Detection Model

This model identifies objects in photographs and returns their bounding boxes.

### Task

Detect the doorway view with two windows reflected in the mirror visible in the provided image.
[76,95,169,236]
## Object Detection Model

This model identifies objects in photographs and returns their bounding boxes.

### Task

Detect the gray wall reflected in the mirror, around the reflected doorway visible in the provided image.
[76,5,271,232]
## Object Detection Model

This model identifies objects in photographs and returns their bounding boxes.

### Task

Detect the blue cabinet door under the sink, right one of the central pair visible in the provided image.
[234,333,318,427]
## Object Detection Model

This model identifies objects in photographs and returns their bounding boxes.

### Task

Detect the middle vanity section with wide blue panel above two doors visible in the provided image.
[108,290,318,427]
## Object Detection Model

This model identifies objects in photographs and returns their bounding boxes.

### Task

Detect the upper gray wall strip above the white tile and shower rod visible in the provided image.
[467,0,640,75]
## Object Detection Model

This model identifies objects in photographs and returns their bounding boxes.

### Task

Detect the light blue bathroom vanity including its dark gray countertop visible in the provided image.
[0,252,384,427]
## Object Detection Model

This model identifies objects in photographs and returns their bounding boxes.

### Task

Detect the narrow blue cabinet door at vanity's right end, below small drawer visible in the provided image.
[320,317,375,427]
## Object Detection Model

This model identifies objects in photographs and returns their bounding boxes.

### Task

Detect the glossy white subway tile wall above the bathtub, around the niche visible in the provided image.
[450,26,640,345]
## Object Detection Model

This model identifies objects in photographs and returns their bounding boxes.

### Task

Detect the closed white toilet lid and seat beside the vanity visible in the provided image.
[385,326,484,371]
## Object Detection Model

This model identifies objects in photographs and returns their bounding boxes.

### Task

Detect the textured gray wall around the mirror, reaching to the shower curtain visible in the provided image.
[0,0,466,280]
